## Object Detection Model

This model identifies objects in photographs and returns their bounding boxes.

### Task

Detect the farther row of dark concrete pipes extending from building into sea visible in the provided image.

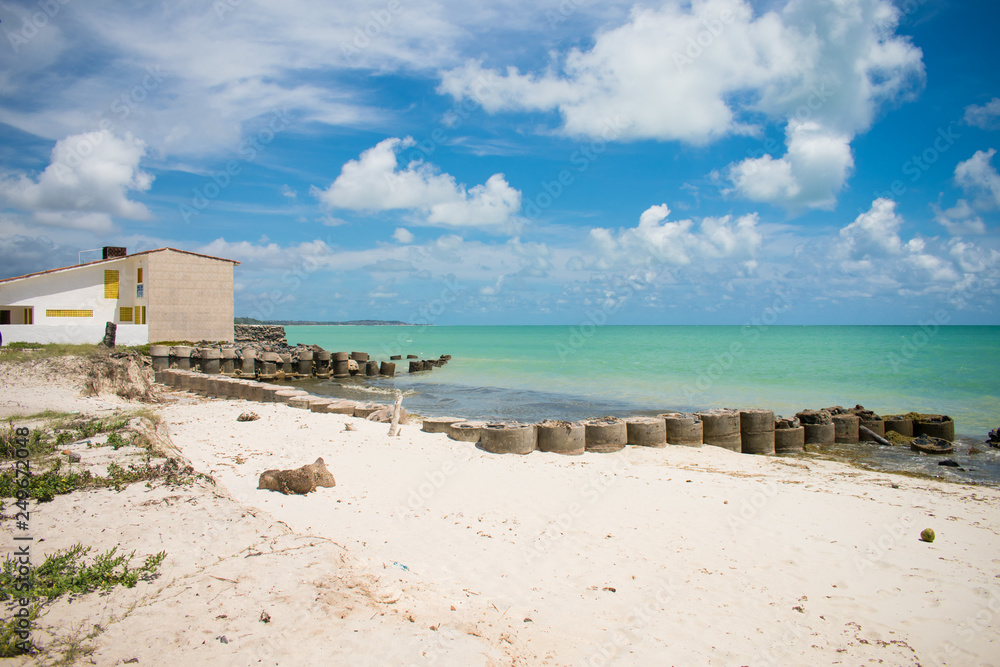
[149,345,451,380]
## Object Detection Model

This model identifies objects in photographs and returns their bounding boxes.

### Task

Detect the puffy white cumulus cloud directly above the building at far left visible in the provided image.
[0,130,153,232]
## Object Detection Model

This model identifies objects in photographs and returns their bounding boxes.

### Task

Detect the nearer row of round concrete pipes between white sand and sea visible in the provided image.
[422,409,955,455]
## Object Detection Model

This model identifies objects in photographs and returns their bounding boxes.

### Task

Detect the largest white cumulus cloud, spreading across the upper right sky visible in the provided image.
[440,0,924,207]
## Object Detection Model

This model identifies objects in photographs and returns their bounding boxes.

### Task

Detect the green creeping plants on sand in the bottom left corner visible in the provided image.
[0,544,167,664]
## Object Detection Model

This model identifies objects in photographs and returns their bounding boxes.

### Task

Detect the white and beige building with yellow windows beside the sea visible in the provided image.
[0,247,239,345]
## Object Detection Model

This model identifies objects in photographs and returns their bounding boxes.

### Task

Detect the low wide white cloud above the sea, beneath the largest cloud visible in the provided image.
[590,204,763,268]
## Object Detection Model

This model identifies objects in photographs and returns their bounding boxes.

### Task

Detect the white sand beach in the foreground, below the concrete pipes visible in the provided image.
[0,364,1000,667]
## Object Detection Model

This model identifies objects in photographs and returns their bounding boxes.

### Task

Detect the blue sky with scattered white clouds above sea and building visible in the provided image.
[0,0,1000,324]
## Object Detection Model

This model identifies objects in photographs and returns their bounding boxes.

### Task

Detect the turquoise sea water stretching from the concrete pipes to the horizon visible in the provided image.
[286,325,1000,440]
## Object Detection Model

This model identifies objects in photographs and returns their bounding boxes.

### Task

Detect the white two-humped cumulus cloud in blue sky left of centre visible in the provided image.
[312,137,521,234]
